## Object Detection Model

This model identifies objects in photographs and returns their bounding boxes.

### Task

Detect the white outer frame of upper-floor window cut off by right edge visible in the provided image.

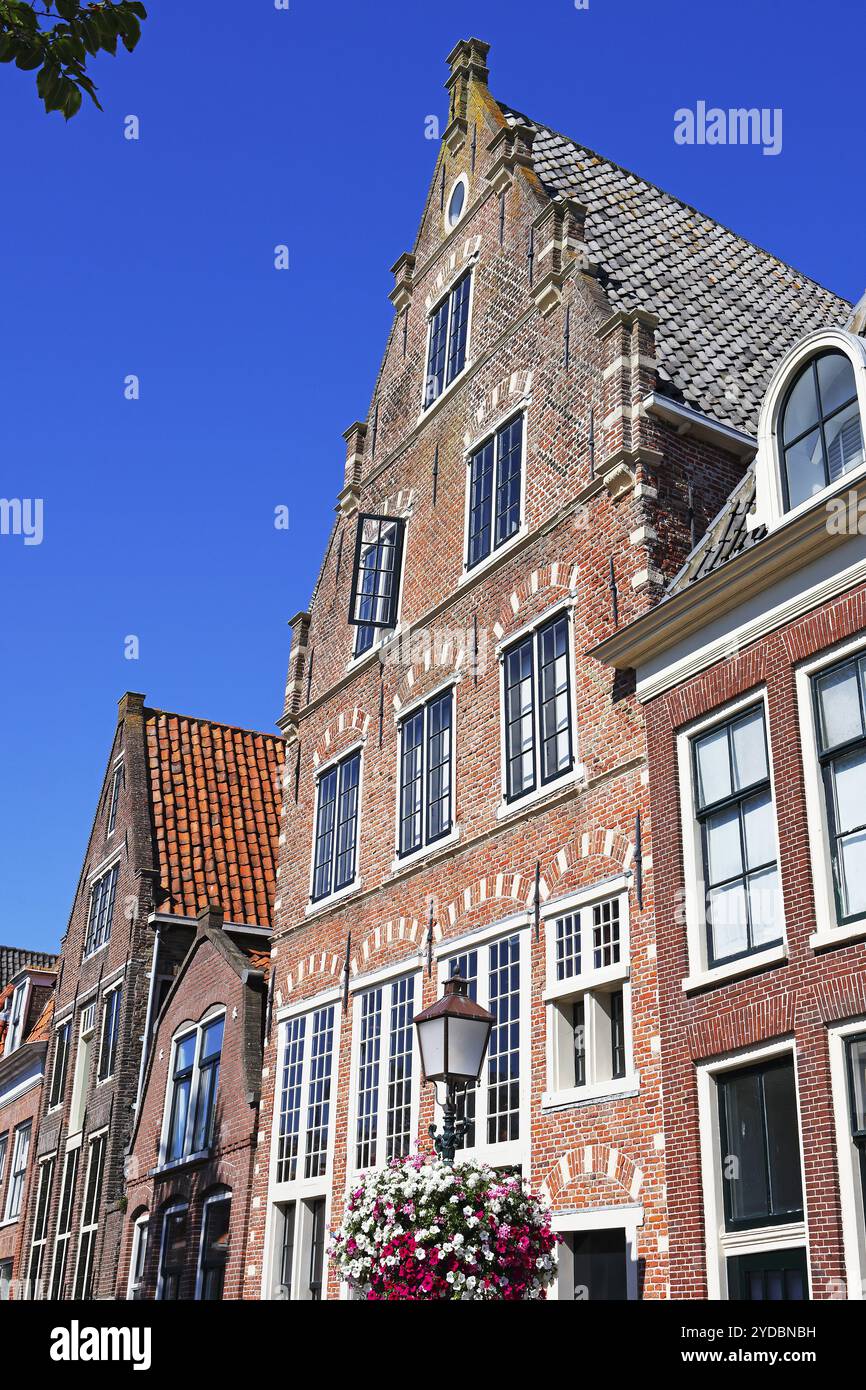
[795,636,866,951]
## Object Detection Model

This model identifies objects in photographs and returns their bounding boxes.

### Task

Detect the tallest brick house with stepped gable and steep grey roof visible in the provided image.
[240,39,849,1300]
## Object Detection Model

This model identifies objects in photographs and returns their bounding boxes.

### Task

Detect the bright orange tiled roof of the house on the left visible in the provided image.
[145,709,285,927]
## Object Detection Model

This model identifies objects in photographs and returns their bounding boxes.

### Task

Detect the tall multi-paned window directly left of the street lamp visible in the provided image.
[354,976,416,1169]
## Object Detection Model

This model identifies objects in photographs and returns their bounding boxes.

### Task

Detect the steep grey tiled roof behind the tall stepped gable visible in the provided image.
[502,106,851,432]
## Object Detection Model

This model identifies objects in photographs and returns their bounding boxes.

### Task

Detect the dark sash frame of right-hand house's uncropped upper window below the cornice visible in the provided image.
[691,701,784,970]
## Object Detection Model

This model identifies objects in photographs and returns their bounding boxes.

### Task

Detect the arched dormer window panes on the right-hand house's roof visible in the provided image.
[780,350,863,510]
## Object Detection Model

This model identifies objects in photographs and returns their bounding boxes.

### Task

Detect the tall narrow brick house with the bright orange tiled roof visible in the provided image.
[26,694,282,1298]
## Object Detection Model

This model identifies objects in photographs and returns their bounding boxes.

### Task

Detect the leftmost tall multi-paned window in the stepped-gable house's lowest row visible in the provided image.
[277,1004,335,1183]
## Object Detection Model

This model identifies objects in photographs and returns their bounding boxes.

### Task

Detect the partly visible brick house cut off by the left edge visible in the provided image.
[0,947,57,1298]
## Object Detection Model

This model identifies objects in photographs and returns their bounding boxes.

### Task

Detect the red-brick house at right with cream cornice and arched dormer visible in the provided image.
[599,302,866,1300]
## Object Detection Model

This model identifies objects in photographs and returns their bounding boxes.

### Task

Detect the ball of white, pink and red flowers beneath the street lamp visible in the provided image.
[329,1154,557,1302]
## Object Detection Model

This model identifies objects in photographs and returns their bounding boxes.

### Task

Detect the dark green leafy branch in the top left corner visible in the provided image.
[0,0,147,121]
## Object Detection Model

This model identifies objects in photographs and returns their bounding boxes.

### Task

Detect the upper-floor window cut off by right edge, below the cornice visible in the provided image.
[813,656,866,923]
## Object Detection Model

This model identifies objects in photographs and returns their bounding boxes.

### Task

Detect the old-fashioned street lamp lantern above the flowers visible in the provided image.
[416,974,493,1163]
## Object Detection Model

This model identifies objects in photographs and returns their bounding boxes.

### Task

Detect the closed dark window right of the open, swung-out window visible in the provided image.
[466,416,523,570]
